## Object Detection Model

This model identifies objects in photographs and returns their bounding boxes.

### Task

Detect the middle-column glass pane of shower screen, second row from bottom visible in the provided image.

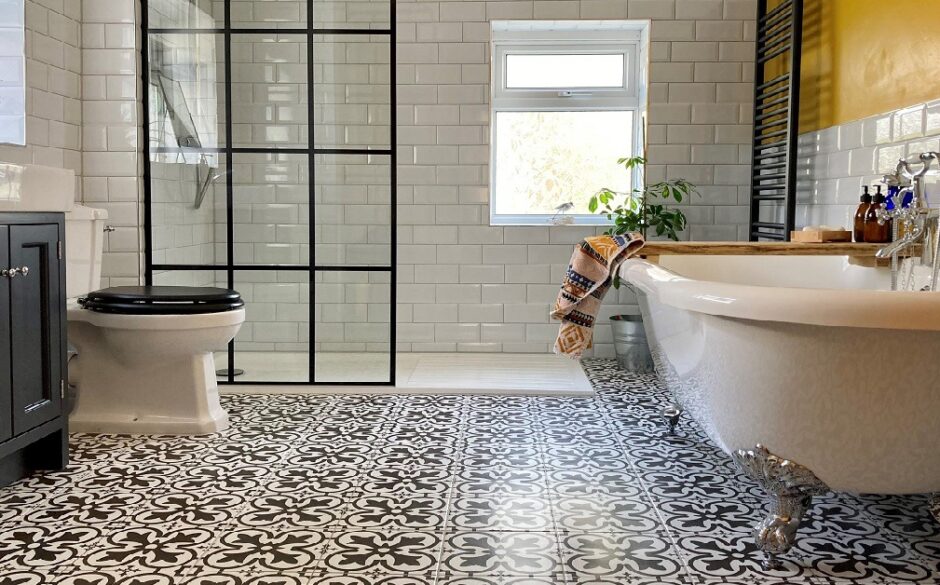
[233,154,310,265]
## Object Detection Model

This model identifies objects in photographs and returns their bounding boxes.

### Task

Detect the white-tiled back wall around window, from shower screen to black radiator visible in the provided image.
[397,0,756,355]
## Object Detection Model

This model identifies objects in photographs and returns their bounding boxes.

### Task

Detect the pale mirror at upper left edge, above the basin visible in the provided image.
[0,0,26,146]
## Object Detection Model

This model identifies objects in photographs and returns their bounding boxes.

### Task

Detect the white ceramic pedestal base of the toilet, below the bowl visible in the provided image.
[69,349,229,435]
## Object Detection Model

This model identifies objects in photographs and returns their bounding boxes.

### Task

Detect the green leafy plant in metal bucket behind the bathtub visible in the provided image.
[588,156,698,372]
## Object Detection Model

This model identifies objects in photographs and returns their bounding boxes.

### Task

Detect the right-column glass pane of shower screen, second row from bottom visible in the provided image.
[314,155,392,266]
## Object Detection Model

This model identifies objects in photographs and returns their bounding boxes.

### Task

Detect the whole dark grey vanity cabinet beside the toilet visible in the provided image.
[0,213,68,485]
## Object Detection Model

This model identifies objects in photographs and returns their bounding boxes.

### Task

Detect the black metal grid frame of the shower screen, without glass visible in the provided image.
[140,0,398,386]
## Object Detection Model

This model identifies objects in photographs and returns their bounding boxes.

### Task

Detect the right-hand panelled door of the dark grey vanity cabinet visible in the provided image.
[9,224,63,435]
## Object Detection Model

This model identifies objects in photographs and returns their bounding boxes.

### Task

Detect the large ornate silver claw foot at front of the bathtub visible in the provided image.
[733,445,829,570]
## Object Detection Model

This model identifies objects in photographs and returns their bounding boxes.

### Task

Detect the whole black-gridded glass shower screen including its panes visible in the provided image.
[142,0,397,385]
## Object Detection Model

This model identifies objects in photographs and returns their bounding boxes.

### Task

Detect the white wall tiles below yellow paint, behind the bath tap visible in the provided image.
[796,100,940,229]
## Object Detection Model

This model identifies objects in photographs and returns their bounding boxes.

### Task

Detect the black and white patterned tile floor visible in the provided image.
[0,360,940,585]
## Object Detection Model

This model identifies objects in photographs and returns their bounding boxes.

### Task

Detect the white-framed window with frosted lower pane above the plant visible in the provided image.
[490,21,648,225]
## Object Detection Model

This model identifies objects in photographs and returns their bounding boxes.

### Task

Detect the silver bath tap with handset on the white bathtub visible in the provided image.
[875,152,940,291]
